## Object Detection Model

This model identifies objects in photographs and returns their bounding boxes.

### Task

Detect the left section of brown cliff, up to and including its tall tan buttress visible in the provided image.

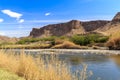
[30,20,85,37]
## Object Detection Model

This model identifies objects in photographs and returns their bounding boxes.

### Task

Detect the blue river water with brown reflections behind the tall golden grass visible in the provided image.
[8,51,120,80]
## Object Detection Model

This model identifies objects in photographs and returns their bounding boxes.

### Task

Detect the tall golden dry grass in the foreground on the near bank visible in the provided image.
[0,51,92,80]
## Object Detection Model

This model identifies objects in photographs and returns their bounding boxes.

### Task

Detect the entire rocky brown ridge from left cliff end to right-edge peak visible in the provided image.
[30,12,120,37]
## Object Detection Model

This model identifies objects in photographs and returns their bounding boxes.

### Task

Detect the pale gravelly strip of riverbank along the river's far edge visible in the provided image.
[4,49,120,55]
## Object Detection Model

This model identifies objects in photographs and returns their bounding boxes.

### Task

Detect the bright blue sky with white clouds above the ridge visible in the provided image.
[0,0,120,37]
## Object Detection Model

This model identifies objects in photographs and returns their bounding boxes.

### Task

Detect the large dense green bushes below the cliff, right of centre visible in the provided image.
[70,34,109,45]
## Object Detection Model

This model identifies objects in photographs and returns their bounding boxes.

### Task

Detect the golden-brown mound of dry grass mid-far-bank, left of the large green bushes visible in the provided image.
[52,41,81,49]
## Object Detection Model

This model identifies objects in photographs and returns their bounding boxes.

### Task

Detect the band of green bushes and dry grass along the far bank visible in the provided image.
[0,34,109,49]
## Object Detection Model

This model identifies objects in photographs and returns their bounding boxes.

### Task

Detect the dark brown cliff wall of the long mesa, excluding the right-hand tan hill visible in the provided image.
[30,20,109,37]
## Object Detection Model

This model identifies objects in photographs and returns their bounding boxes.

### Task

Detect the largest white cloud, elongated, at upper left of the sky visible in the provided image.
[1,9,22,20]
